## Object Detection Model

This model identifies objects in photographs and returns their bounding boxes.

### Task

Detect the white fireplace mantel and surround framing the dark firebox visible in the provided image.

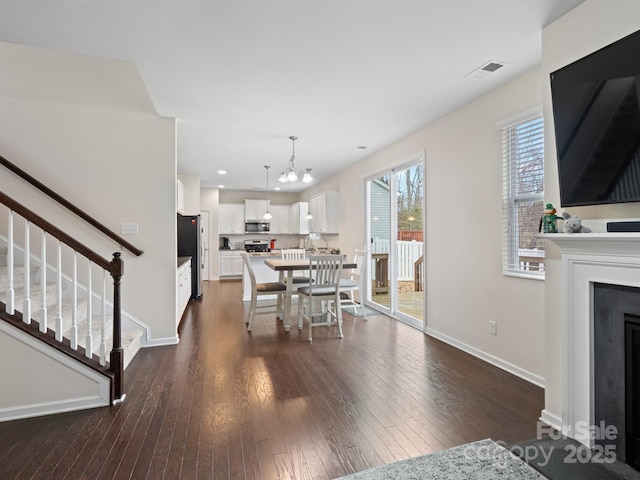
[539,233,640,447]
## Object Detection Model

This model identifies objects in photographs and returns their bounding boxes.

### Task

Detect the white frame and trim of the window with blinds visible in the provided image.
[497,107,544,280]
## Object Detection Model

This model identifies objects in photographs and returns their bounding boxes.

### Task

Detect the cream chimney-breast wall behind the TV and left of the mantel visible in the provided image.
[542,0,640,423]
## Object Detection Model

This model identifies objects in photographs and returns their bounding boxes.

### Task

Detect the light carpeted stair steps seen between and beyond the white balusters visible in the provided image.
[0,246,144,368]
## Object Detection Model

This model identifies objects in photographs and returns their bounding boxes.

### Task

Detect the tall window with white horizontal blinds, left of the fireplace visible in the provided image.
[501,115,544,278]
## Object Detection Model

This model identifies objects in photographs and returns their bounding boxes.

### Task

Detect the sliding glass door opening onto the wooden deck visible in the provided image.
[366,155,425,329]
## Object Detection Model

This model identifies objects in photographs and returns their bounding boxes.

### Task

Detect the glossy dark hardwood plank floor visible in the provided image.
[0,281,543,480]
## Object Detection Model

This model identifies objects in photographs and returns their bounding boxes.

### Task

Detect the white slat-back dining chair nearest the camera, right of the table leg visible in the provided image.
[298,255,343,342]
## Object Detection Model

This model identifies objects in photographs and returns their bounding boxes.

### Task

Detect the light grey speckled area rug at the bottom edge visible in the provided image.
[339,439,547,480]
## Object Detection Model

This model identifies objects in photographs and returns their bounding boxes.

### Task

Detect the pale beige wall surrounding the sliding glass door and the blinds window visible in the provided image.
[312,69,544,384]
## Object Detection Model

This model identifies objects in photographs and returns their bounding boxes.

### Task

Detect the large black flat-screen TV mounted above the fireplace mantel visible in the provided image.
[551,30,640,207]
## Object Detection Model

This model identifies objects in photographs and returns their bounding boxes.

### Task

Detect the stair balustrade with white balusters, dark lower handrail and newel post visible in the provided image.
[0,192,124,403]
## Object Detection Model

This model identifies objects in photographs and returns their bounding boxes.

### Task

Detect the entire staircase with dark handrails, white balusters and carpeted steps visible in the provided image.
[0,156,148,414]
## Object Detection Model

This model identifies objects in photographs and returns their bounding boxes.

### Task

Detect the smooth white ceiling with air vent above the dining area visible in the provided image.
[0,0,584,191]
